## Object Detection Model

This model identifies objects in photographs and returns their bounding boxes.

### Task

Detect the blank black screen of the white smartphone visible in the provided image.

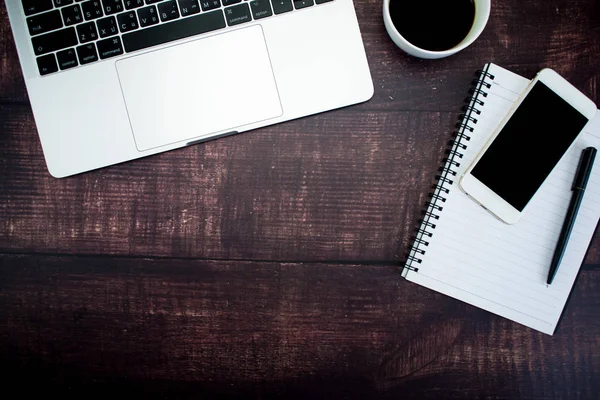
[471,81,588,211]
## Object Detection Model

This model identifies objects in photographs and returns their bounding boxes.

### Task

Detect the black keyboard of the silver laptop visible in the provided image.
[21,0,333,75]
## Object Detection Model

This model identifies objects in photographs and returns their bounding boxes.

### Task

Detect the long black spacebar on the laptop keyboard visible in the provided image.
[122,10,225,52]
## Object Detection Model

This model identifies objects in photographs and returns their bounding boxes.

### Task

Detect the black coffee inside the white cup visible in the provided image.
[390,0,475,51]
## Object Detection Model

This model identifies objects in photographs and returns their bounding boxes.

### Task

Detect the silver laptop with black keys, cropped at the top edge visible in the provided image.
[6,0,373,178]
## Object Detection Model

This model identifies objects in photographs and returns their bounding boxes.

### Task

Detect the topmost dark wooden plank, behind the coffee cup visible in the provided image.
[0,0,600,111]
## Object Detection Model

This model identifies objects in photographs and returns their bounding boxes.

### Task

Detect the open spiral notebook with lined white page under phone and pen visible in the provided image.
[402,64,600,335]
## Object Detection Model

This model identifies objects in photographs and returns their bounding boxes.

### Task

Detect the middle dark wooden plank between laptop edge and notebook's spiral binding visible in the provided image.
[0,106,600,263]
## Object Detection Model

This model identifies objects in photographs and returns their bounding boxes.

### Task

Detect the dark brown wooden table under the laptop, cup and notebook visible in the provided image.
[0,0,600,399]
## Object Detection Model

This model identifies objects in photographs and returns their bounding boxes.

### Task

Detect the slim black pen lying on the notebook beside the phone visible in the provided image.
[547,147,596,285]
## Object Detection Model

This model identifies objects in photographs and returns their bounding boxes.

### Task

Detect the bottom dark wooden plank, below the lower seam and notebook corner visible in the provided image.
[0,255,600,399]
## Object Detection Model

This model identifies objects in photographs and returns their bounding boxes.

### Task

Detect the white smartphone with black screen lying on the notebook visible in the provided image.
[460,69,597,224]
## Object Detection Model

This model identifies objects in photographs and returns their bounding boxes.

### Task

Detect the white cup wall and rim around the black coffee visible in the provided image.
[383,0,491,59]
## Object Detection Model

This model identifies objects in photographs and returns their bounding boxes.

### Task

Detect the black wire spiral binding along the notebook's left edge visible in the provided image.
[402,66,494,276]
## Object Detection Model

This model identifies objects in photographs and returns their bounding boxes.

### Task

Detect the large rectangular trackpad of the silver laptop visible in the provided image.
[117,25,283,151]
